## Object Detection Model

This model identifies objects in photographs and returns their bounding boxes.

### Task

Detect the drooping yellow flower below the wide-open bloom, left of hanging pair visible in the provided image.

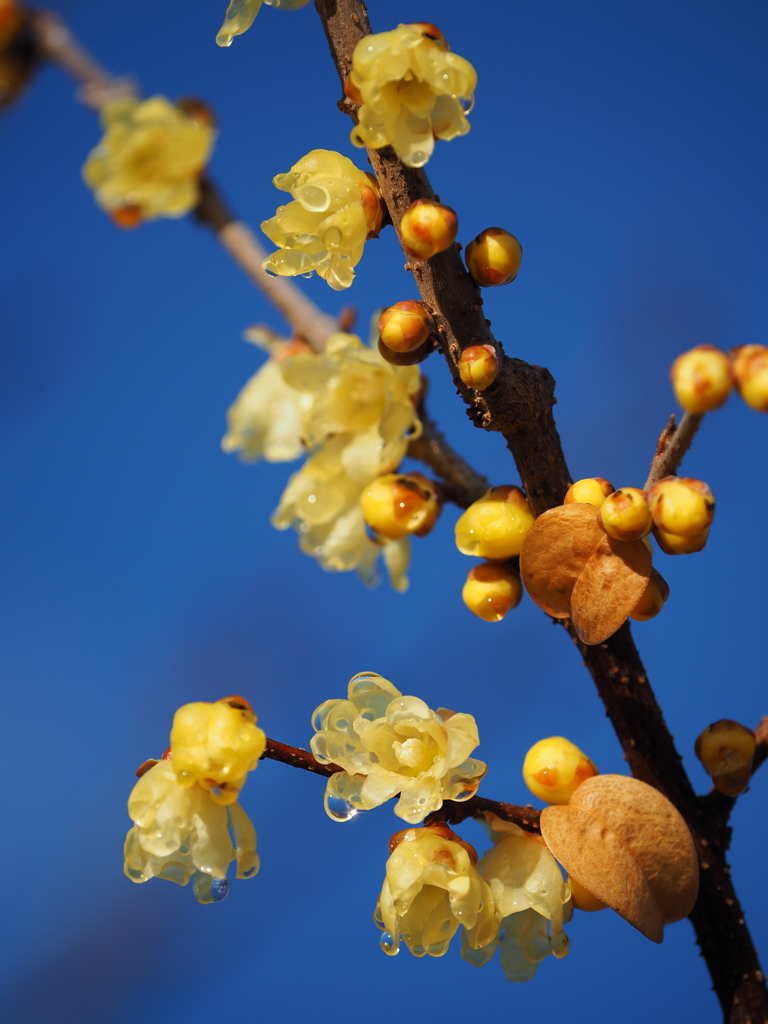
[374,825,499,956]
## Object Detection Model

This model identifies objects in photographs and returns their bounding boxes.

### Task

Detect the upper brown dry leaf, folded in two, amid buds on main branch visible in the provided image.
[520,504,651,644]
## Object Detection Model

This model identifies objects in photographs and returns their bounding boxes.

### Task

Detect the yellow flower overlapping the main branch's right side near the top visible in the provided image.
[347,25,477,167]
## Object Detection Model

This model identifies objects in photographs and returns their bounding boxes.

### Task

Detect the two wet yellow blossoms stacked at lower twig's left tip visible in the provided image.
[125,697,266,903]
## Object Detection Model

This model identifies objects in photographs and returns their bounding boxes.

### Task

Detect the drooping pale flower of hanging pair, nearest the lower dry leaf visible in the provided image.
[462,814,570,981]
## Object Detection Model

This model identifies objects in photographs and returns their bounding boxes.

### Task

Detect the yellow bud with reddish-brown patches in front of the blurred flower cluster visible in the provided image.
[360,473,440,541]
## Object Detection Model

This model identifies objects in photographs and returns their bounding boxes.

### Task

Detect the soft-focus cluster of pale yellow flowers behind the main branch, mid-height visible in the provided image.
[222,332,428,591]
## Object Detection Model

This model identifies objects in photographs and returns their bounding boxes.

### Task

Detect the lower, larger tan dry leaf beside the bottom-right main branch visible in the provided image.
[542,775,698,942]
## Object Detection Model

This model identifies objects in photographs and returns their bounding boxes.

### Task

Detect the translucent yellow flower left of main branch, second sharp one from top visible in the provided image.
[261,150,382,292]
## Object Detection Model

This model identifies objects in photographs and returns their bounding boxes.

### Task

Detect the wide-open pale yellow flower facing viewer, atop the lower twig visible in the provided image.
[311,672,486,824]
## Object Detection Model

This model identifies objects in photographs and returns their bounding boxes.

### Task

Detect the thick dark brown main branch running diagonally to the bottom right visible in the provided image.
[315,0,768,1024]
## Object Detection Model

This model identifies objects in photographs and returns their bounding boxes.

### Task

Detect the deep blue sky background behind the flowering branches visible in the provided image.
[0,0,768,1024]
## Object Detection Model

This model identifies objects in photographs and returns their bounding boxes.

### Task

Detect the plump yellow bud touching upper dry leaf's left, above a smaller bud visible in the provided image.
[456,485,534,561]
